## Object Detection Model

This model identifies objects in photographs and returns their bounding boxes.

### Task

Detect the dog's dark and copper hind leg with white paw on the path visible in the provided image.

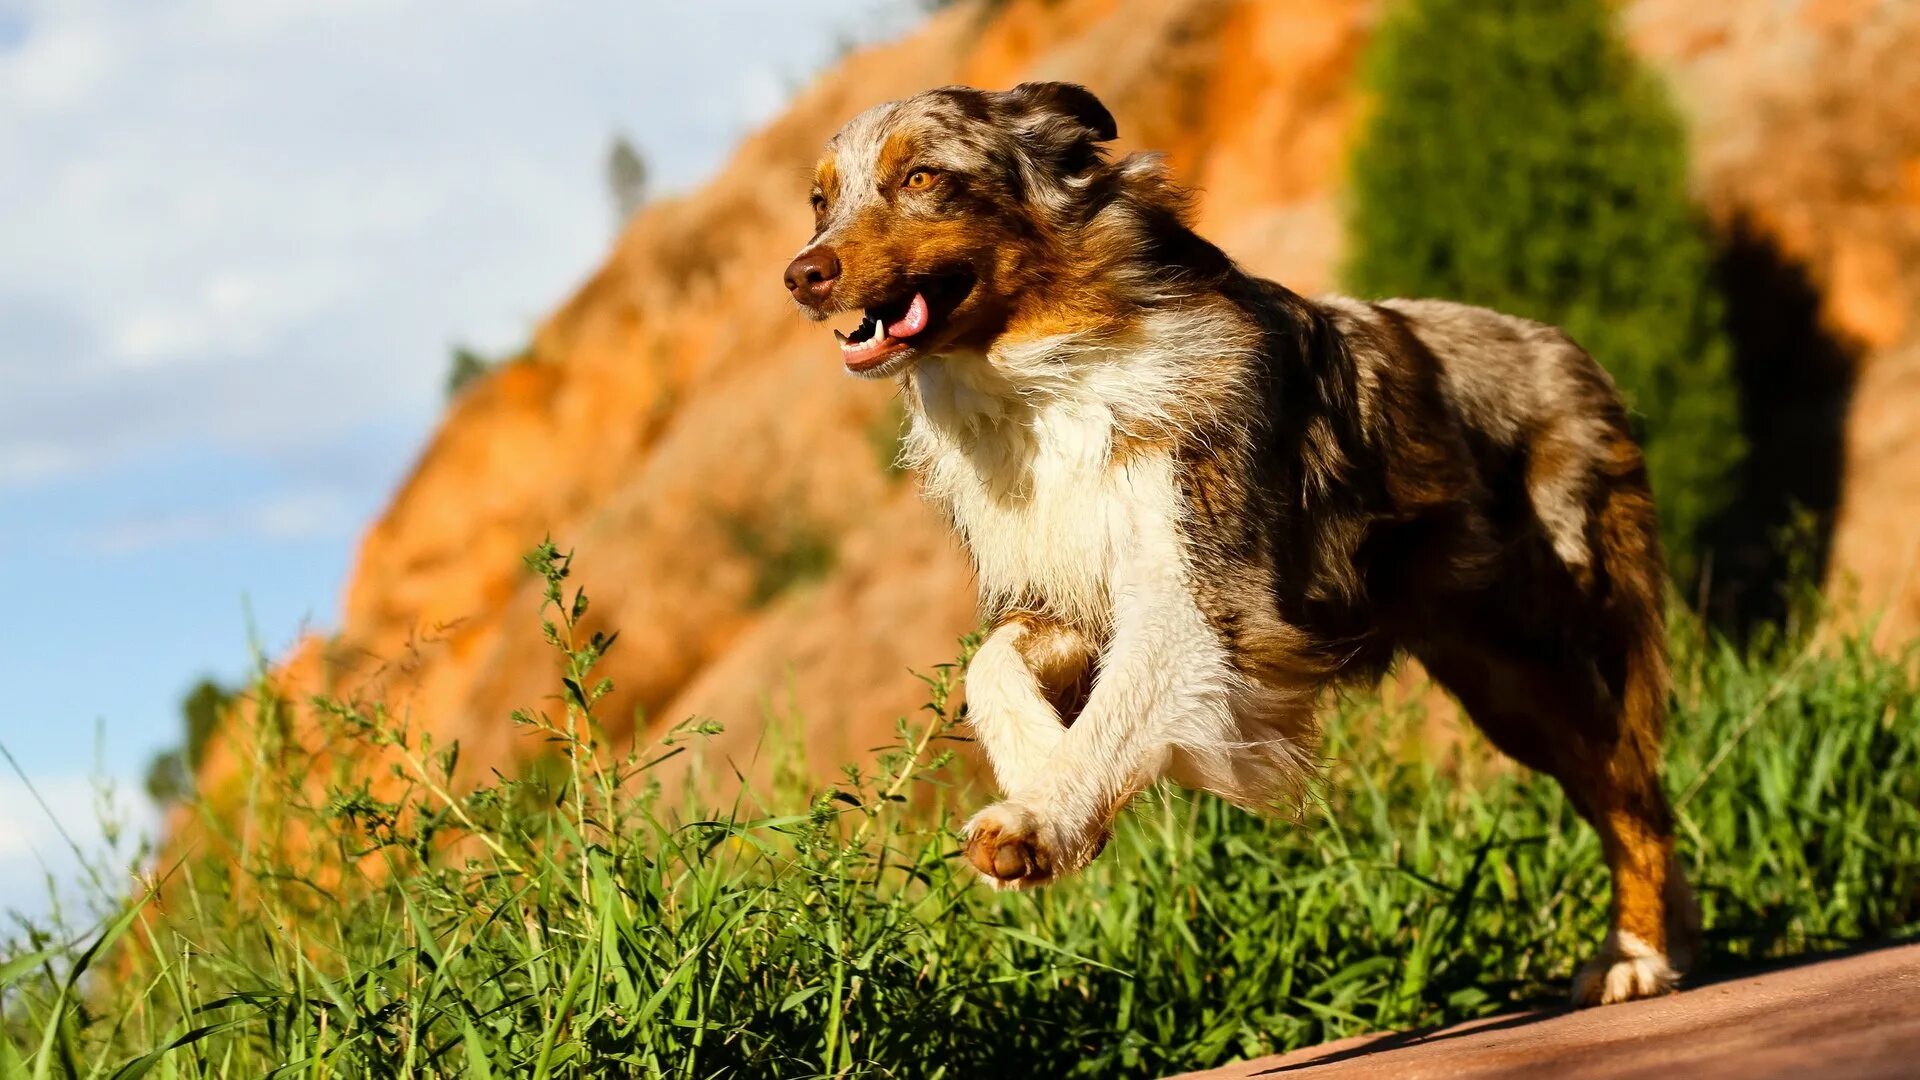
[1411,453,1699,1005]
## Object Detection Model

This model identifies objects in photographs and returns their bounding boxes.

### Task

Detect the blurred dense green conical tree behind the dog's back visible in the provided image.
[1346,0,1745,575]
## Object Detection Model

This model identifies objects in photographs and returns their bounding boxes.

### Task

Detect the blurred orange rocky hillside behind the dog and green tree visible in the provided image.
[191,0,1920,790]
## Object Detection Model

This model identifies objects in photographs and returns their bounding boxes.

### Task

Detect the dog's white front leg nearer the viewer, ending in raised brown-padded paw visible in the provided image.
[966,518,1227,888]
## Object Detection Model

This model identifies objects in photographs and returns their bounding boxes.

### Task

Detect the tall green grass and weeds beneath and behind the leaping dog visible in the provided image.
[0,546,1920,1078]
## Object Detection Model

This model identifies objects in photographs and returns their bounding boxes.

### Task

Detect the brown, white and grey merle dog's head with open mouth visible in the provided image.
[785,83,1116,377]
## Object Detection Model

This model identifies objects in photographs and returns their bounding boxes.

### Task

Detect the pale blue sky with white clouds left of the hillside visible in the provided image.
[0,0,918,922]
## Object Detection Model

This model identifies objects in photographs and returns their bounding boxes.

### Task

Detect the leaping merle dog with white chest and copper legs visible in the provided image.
[785,83,1697,1003]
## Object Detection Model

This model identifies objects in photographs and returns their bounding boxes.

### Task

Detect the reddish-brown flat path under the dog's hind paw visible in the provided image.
[1187,945,1920,1080]
